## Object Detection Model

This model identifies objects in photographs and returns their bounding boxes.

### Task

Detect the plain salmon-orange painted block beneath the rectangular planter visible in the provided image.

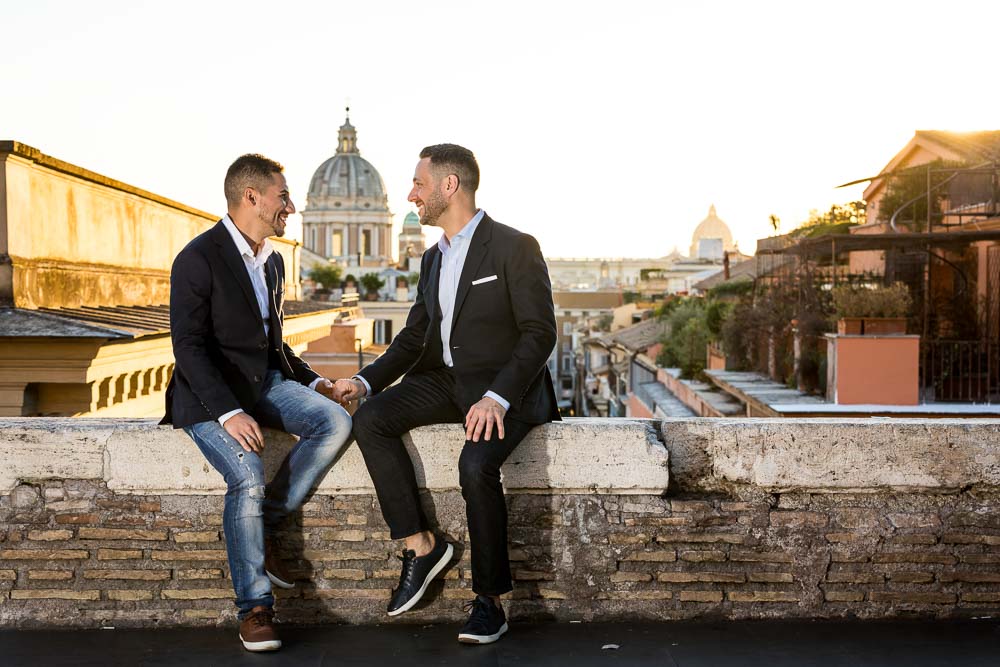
[835,336,920,405]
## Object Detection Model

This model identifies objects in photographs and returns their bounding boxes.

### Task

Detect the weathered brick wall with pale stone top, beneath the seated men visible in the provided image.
[0,420,1000,627]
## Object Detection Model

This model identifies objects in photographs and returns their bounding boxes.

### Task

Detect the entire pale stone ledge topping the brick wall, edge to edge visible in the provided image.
[0,418,1000,494]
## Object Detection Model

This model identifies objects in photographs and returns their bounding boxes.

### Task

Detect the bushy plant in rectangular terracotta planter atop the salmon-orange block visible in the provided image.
[832,283,913,336]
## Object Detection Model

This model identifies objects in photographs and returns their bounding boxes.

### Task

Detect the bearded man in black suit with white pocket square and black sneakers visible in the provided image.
[335,144,559,644]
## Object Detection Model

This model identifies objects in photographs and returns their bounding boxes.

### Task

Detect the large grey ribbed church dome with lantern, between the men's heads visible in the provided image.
[308,111,389,211]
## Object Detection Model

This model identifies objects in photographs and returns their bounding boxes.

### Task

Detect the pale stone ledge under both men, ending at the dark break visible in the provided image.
[0,418,669,495]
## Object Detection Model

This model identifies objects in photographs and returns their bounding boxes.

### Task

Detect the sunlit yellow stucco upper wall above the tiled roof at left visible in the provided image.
[0,142,299,308]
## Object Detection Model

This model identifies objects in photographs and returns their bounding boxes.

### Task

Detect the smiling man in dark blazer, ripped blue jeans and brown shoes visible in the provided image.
[162,155,351,651]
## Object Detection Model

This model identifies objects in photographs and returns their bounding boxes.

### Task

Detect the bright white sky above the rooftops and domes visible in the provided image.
[0,0,1000,257]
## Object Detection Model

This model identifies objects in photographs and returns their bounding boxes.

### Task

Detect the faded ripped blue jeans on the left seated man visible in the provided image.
[184,371,351,620]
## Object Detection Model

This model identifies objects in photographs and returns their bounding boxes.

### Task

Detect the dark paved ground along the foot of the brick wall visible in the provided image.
[0,619,1000,667]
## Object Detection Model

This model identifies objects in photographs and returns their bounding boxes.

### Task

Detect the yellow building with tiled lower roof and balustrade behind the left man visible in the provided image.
[0,141,344,417]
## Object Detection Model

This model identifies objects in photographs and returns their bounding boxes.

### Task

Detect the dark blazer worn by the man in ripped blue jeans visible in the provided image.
[160,221,319,428]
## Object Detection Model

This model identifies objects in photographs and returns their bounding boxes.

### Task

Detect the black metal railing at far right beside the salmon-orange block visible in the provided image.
[920,340,1000,403]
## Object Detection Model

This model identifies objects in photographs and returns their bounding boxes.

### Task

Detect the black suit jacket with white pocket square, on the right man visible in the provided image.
[359,215,559,424]
